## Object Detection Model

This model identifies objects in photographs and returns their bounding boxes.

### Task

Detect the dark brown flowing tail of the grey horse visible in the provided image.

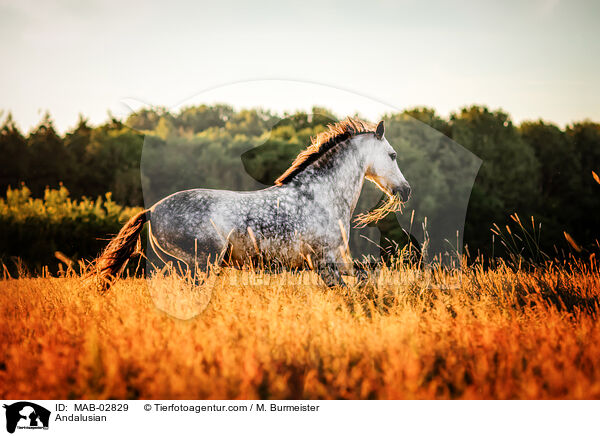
[87,209,150,291]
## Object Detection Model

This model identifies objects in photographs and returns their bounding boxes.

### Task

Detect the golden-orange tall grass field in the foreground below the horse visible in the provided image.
[0,261,600,399]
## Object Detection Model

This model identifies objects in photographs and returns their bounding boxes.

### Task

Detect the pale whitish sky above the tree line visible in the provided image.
[0,0,600,132]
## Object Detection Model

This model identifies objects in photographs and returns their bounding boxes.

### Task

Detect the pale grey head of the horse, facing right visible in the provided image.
[364,121,410,201]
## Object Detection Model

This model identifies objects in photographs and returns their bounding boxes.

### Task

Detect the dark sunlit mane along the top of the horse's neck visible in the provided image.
[275,117,375,186]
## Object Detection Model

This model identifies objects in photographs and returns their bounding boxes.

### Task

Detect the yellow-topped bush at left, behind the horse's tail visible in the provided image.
[0,185,141,275]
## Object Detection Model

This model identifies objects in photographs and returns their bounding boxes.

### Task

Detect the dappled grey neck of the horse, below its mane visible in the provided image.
[300,145,365,222]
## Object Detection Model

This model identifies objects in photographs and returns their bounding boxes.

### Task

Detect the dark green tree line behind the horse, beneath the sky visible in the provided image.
[0,105,600,266]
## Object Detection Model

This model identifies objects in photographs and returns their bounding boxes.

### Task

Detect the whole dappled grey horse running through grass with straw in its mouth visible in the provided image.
[91,117,411,289]
